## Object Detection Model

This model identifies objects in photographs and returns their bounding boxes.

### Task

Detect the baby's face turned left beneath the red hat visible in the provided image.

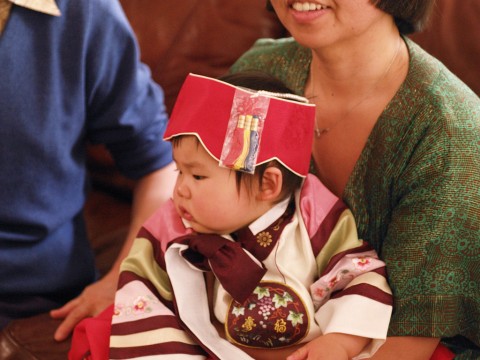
[173,136,261,234]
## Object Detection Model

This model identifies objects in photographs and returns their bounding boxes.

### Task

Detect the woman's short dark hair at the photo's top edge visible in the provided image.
[267,0,436,35]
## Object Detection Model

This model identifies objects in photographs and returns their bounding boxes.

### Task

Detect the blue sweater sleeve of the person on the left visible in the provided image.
[85,0,172,179]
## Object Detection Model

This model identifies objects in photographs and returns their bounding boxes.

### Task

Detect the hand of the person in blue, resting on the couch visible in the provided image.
[50,272,117,341]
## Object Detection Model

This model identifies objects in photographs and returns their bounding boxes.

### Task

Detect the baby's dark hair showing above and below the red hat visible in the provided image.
[219,71,303,202]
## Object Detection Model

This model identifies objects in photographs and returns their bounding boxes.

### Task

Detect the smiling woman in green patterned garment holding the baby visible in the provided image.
[232,0,480,359]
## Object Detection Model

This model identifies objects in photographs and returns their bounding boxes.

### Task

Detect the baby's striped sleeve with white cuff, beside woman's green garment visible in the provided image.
[310,206,393,358]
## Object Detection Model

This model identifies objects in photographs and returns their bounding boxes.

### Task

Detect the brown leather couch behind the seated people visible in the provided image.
[0,0,480,360]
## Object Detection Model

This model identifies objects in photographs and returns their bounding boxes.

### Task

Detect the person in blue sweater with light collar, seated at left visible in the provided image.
[0,0,175,340]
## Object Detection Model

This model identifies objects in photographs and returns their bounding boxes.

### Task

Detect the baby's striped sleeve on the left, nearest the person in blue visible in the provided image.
[110,229,206,360]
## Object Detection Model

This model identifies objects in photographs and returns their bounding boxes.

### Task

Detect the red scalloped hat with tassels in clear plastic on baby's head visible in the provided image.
[164,74,315,176]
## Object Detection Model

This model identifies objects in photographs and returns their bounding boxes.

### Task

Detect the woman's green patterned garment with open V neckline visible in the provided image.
[231,38,480,359]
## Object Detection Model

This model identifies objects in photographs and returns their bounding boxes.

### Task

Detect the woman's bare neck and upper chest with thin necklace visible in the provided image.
[305,23,408,196]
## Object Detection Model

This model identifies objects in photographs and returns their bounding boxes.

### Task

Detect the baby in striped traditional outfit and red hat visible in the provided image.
[72,74,392,360]
